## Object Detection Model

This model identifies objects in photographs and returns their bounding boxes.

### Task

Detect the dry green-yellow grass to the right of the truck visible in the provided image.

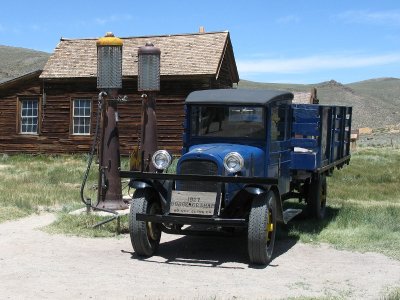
[282,148,400,260]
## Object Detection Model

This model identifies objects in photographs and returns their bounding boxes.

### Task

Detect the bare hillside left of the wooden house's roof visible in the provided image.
[0,45,50,83]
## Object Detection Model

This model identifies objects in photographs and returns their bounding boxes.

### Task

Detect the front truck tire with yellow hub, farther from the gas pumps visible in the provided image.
[247,191,277,265]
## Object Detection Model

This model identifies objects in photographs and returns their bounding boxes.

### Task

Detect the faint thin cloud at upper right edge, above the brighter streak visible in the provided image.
[336,10,400,25]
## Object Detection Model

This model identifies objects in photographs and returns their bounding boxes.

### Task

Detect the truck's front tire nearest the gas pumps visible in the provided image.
[129,189,161,257]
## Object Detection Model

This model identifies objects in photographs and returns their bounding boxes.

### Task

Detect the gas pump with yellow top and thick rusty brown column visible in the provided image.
[96,33,128,210]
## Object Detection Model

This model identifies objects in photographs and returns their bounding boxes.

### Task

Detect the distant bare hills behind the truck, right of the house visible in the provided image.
[238,78,400,128]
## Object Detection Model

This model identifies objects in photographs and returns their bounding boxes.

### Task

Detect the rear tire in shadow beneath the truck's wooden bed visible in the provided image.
[307,175,327,220]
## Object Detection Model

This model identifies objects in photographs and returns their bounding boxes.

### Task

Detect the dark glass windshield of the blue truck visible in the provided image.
[190,105,265,139]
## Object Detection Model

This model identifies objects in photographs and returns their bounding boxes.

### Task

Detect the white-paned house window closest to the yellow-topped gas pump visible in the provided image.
[72,99,91,135]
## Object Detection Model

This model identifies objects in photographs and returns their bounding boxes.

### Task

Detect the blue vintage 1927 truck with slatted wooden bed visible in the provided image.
[121,89,352,265]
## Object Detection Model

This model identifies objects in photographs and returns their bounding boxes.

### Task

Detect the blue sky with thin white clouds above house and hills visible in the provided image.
[0,0,400,83]
